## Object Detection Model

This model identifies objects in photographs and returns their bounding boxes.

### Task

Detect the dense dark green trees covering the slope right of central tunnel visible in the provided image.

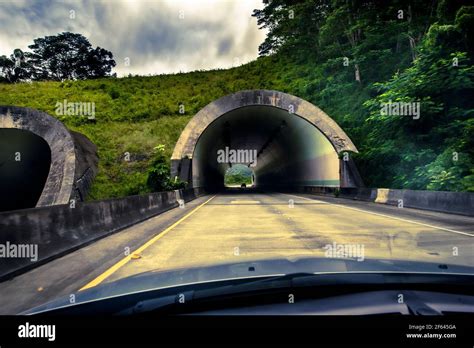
[254,0,474,191]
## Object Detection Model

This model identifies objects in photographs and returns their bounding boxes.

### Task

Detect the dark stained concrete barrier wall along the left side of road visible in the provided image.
[0,188,203,280]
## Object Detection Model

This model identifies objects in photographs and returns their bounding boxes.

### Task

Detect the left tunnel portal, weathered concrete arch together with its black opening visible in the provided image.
[0,105,99,212]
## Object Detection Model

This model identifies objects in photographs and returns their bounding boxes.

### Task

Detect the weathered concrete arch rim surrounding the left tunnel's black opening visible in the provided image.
[0,106,98,210]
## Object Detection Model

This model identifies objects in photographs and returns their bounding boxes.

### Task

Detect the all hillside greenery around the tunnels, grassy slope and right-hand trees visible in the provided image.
[0,0,474,199]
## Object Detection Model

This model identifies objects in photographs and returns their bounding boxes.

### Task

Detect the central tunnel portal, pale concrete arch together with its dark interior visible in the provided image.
[171,90,363,190]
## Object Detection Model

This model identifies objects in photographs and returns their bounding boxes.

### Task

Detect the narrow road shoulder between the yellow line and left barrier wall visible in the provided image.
[0,196,209,314]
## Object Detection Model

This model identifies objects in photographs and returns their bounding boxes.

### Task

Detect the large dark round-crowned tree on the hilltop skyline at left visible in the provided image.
[25,32,116,81]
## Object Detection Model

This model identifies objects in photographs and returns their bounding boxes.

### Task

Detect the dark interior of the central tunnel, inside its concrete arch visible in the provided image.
[192,105,339,191]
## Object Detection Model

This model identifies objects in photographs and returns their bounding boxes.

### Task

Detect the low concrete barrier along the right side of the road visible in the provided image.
[298,186,474,216]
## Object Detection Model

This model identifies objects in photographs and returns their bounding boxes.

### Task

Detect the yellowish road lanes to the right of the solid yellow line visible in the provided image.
[91,194,474,285]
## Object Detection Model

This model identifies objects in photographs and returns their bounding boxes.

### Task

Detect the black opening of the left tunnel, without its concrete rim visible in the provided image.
[0,128,51,211]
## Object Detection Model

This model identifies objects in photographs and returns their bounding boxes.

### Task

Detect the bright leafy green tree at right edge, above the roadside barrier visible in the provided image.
[361,7,474,191]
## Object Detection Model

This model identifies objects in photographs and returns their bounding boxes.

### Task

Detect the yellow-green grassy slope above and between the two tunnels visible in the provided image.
[0,58,300,200]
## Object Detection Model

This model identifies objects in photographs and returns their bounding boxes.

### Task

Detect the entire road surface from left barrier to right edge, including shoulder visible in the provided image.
[0,193,474,314]
